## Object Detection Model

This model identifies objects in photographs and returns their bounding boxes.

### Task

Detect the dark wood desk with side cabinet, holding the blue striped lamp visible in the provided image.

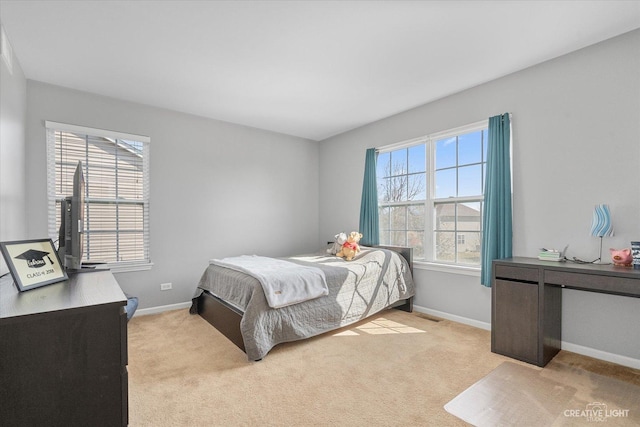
[491,258,640,366]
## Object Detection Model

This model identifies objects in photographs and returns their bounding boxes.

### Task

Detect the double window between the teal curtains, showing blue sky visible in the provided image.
[376,121,488,266]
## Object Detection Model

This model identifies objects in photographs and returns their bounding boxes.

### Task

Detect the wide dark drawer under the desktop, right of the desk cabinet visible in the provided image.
[544,270,640,298]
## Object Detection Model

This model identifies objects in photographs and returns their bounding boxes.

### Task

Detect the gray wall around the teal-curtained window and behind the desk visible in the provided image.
[320,31,640,363]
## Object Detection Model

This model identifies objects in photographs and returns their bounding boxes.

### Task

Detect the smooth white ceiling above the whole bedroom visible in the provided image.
[0,0,640,140]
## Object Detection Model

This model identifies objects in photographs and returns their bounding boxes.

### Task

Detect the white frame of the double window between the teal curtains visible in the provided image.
[376,119,489,276]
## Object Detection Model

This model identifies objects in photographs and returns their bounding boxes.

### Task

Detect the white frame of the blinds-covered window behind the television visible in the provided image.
[45,121,153,273]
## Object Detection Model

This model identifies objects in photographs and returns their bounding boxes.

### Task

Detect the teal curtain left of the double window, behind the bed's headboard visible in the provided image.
[360,148,380,246]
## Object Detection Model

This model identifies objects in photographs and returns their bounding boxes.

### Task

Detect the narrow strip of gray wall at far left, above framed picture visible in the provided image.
[0,30,27,274]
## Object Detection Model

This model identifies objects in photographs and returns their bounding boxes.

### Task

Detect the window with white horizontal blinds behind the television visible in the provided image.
[46,122,151,271]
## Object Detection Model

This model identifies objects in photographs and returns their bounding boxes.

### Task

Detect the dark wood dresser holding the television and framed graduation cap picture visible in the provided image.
[0,270,129,426]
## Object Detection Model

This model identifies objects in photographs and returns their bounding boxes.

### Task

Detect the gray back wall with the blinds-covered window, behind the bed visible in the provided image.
[26,80,319,308]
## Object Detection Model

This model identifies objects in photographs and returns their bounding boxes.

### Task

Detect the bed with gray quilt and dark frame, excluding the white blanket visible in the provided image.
[190,246,415,361]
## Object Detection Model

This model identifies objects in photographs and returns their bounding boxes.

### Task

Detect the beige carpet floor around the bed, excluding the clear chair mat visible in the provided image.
[129,309,640,426]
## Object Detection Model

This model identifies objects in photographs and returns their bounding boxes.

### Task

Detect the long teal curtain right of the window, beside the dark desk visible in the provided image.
[480,113,513,286]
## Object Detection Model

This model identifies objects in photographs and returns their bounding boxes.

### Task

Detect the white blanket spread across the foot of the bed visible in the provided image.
[209,255,329,308]
